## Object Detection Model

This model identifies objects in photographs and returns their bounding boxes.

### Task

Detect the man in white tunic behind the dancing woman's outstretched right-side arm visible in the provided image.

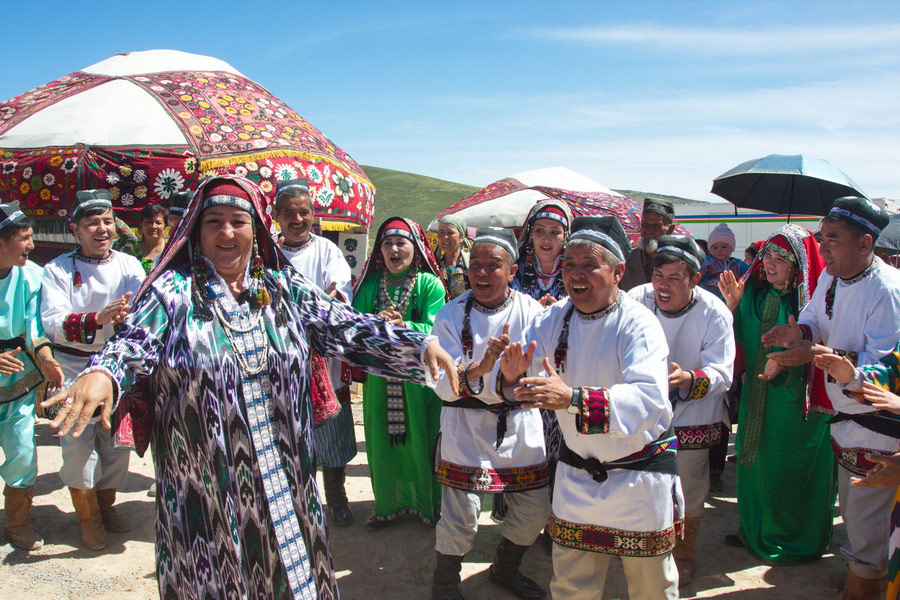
[274,178,356,527]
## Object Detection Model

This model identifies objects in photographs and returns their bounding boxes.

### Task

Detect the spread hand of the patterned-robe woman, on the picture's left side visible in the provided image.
[41,371,113,437]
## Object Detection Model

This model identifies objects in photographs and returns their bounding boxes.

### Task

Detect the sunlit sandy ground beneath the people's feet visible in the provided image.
[0,408,846,600]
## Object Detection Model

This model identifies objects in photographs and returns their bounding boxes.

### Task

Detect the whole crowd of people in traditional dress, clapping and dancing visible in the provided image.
[0,176,900,600]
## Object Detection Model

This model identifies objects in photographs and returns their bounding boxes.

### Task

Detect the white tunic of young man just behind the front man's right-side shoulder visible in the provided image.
[628,283,735,450]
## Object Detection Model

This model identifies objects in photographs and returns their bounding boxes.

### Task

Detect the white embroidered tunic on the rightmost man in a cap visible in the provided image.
[797,256,900,452]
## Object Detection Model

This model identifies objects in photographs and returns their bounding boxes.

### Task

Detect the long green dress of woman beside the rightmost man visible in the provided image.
[734,282,836,565]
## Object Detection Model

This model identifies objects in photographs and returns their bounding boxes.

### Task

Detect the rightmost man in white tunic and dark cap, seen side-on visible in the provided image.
[762,197,900,599]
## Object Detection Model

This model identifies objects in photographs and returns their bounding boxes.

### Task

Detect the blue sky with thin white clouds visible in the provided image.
[0,1,900,200]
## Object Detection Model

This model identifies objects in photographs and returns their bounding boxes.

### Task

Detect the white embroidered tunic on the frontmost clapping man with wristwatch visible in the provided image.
[512,292,684,556]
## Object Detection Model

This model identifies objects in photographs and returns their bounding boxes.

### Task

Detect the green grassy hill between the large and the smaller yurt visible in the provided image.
[362,165,478,236]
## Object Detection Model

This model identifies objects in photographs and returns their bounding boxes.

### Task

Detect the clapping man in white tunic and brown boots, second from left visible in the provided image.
[41,190,144,550]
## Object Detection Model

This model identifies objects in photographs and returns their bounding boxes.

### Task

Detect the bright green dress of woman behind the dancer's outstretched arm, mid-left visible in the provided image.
[353,271,445,524]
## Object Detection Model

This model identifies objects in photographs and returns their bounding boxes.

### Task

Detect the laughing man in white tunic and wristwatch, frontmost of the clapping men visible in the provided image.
[499,217,683,600]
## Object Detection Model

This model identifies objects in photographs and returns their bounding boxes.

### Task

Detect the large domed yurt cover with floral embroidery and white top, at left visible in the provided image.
[0,50,375,230]
